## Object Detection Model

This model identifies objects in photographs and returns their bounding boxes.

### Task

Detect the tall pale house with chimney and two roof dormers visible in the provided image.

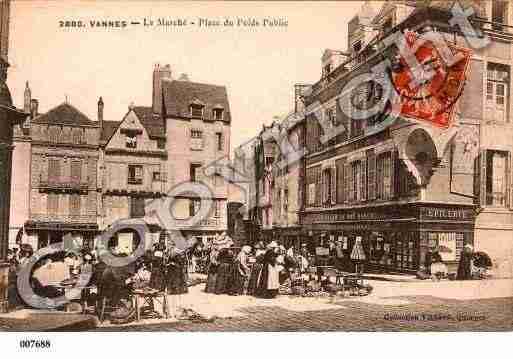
[153,65,232,245]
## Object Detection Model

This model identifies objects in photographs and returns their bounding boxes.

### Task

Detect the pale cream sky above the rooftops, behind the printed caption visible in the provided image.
[7,1,361,149]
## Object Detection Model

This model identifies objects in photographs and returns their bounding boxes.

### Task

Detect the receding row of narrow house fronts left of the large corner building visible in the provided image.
[246,84,310,247]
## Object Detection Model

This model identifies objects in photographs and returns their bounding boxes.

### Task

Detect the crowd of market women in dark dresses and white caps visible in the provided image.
[4,233,491,312]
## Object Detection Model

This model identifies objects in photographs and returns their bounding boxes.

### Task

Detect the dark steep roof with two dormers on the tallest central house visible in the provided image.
[162,80,231,122]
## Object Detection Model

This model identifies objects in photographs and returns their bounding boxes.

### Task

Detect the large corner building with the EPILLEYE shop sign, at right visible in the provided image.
[301,1,513,275]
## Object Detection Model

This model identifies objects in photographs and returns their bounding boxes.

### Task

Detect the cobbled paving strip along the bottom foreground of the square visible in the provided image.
[97,296,513,332]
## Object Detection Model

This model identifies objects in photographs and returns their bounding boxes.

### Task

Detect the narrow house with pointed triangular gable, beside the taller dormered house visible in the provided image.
[98,97,168,251]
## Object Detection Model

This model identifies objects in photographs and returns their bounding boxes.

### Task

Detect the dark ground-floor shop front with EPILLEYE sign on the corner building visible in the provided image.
[303,203,475,273]
